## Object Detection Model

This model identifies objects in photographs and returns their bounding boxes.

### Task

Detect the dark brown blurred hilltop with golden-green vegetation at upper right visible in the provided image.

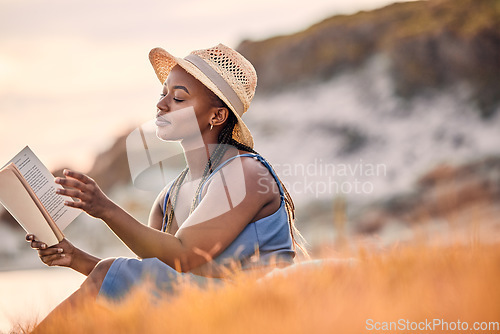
[238,0,500,117]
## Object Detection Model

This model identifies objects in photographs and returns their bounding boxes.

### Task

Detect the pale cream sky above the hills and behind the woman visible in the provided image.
[0,0,414,171]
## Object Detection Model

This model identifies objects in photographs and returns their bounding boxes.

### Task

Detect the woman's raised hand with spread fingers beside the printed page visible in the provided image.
[55,169,113,218]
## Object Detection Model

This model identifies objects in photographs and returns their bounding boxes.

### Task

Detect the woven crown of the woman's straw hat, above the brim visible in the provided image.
[191,44,257,112]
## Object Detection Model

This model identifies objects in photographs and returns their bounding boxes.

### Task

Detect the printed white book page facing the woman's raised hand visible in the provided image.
[9,146,81,231]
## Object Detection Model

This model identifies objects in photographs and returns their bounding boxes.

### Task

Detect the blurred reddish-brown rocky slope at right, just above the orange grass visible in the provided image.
[353,156,500,237]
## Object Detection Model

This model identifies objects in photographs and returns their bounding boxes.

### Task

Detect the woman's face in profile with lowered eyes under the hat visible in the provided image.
[156,65,217,141]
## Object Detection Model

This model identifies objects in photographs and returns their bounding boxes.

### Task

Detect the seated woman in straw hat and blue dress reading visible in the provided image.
[27,44,308,325]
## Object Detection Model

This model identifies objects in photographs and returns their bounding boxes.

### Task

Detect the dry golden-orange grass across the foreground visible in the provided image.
[13,237,500,334]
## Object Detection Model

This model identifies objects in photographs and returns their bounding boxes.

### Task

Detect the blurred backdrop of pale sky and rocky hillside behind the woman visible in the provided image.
[0,0,500,330]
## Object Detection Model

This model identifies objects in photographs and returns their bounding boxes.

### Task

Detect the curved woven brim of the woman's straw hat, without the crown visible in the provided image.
[149,48,253,148]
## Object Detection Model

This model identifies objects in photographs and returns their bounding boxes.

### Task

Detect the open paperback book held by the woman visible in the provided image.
[0,146,81,246]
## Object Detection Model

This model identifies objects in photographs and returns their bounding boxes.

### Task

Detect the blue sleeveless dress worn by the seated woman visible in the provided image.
[99,154,295,300]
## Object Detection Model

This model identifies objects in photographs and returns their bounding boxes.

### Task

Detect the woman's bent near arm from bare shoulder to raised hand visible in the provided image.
[57,159,276,271]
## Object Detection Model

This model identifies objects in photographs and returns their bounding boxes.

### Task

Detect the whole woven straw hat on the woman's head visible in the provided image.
[149,44,257,148]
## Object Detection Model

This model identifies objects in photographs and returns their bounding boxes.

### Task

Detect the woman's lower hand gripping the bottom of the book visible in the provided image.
[26,234,76,267]
